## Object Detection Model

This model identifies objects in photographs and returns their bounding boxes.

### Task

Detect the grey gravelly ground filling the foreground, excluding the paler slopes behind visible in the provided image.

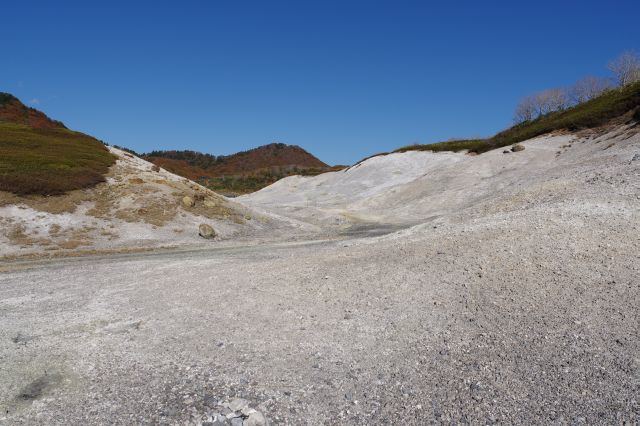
[0,211,640,425]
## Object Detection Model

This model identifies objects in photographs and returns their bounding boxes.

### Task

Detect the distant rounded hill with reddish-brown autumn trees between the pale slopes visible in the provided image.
[142,143,335,195]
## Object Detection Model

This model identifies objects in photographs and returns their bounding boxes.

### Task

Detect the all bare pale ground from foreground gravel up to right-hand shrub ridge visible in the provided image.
[0,128,640,425]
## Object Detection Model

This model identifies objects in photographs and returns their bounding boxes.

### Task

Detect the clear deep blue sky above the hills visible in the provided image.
[0,0,640,164]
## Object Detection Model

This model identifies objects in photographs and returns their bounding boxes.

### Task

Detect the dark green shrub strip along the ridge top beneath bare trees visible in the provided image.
[394,82,640,154]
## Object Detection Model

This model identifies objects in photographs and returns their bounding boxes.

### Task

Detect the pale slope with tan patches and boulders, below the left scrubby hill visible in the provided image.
[0,147,310,258]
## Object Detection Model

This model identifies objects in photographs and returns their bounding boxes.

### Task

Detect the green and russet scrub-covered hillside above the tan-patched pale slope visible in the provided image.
[0,93,115,195]
